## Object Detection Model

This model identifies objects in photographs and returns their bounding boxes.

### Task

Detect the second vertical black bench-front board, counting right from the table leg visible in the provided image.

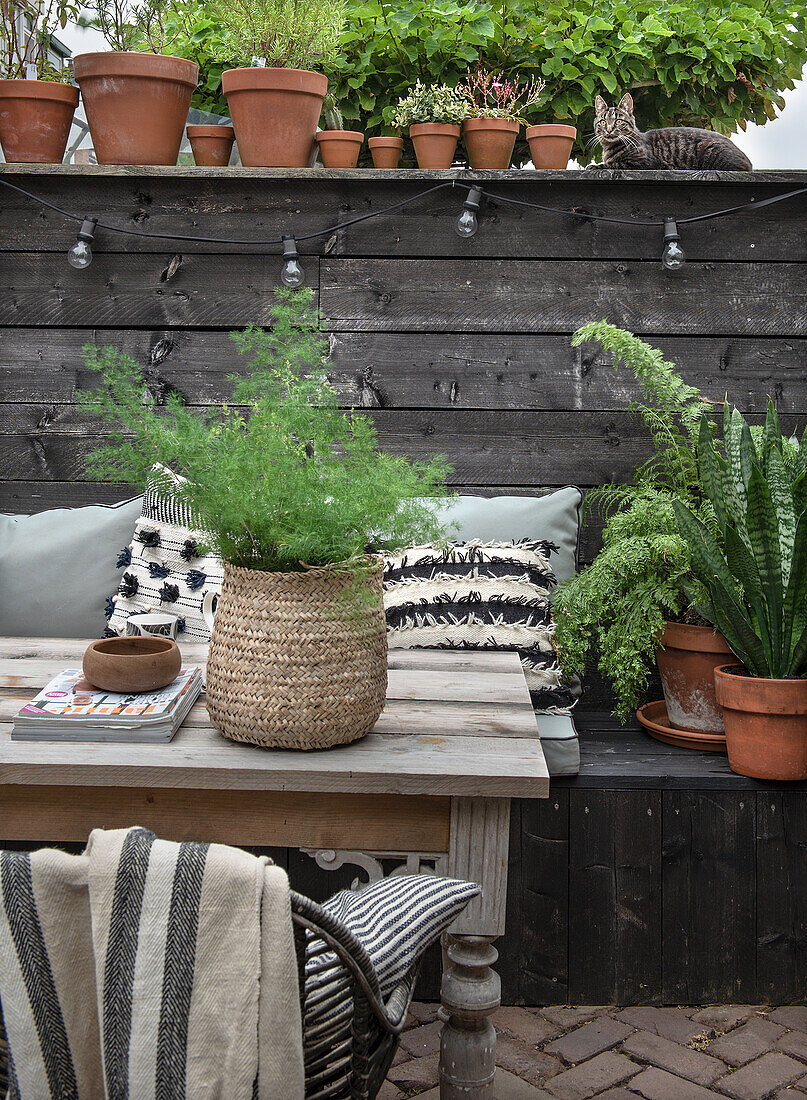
[568,790,662,1004]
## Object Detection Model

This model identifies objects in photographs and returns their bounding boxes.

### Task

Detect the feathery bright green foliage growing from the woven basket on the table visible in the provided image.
[79,288,449,571]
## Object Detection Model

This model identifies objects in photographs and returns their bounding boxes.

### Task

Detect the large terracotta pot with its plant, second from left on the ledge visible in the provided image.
[74,0,199,165]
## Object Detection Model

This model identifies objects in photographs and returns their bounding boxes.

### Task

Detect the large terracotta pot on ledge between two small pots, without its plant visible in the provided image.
[221,67,328,168]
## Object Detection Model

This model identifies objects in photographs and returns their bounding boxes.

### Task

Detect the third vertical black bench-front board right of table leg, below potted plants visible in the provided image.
[662,791,758,1004]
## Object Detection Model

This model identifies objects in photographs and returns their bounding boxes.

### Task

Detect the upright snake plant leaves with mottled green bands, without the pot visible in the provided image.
[673,404,807,679]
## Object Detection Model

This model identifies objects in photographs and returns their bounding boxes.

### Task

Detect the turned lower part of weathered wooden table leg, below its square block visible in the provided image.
[440,935,501,1100]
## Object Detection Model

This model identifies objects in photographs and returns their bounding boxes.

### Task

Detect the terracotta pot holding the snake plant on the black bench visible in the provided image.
[715,664,807,780]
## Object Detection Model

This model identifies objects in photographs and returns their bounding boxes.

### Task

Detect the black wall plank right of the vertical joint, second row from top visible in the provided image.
[320,257,807,337]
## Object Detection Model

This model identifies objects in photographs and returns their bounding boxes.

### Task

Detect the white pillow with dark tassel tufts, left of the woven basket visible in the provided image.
[107,471,223,642]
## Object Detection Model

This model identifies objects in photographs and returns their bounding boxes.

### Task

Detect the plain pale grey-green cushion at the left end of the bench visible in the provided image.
[0,497,143,638]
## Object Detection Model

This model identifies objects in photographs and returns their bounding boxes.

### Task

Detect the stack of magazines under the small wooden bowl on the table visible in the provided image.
[11,668,202,741]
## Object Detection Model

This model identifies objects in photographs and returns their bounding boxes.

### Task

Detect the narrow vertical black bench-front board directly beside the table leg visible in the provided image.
[518,789,576,1004]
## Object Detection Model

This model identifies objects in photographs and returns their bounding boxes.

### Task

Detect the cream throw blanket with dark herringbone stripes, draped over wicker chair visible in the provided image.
[0,828,305,1100]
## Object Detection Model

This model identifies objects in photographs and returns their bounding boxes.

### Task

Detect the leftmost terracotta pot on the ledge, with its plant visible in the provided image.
[0,0,79,164]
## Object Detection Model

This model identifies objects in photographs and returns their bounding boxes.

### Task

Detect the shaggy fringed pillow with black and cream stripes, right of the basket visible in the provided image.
[384,539,575,714]
